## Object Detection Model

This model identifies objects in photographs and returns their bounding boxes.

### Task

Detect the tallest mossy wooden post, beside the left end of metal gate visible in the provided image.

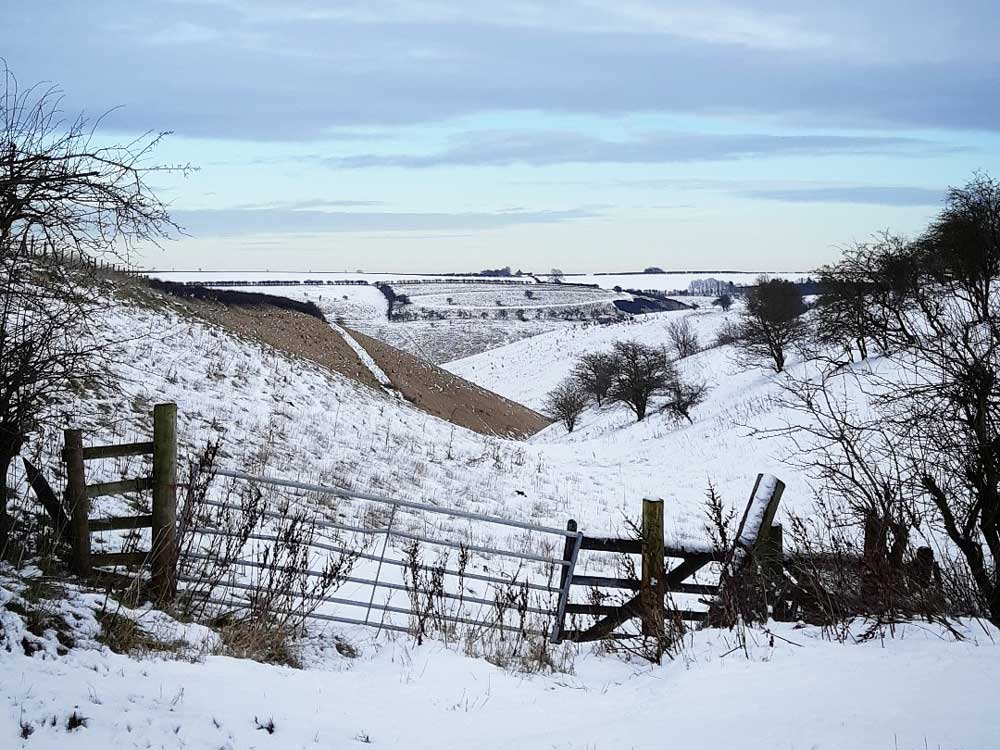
[151,404,177,603]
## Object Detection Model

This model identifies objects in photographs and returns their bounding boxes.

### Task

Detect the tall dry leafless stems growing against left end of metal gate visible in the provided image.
[178,452,366,665]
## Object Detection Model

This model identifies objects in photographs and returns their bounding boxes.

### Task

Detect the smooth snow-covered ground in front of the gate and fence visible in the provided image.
[0,589,1000,750]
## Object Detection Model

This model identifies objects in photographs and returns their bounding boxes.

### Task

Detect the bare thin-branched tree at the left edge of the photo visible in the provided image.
[0,68,174,548]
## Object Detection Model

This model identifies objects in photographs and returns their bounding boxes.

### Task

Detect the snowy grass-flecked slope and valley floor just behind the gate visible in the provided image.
[49,296,796,552]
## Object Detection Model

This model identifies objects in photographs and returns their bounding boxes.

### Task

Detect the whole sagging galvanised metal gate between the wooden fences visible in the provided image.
[178,470,583,642]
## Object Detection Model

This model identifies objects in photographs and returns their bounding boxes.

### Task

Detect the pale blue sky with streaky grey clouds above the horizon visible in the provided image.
[7,0,1000,273]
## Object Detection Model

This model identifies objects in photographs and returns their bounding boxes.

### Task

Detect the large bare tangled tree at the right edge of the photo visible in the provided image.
[772,175,1000,624]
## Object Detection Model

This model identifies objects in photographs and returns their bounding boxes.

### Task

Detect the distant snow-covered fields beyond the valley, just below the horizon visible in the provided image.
[143,271,802,364]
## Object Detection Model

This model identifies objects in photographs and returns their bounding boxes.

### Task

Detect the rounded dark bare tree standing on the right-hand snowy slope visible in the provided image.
[737,277,807,372]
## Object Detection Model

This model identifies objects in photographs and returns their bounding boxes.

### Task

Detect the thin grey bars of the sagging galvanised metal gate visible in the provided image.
[180,469,583,643]
